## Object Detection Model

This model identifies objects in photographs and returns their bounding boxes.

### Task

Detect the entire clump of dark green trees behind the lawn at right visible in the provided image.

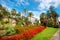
[40,6,59,26]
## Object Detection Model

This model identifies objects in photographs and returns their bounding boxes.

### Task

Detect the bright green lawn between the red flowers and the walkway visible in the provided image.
[31,27,58,40]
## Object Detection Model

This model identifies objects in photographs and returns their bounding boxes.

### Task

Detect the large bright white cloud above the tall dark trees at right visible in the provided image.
[35,0,60,10]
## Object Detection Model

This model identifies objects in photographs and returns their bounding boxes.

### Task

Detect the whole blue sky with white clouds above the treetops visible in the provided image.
[0,0,60,17]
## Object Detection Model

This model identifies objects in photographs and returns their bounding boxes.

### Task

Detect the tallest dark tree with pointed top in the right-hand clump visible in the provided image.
[47,6,59,25]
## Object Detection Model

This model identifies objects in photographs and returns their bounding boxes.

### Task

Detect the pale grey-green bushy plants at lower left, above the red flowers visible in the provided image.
[0,24,16,36]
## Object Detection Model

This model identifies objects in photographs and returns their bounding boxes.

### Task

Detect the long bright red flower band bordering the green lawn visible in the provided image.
[0,27,45,40]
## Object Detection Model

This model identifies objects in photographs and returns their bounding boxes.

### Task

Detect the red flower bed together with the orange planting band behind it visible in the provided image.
[1,27,45,40]
